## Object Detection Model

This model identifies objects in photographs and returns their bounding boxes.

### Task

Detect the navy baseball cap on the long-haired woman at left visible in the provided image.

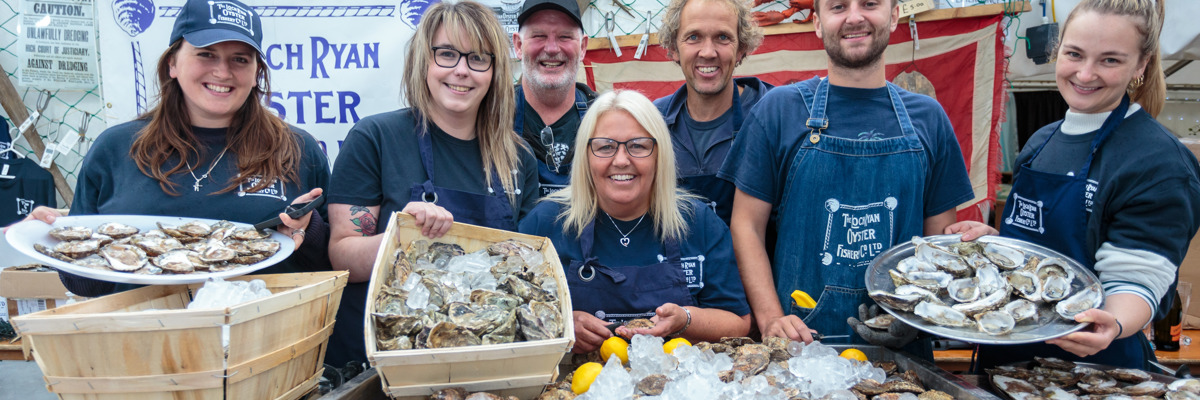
[168,0,263,54]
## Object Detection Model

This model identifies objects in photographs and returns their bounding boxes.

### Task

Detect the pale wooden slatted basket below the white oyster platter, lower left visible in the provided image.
[13,271,349,400]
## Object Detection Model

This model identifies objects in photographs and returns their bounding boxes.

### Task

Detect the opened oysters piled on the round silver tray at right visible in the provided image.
[866,237,1103,336]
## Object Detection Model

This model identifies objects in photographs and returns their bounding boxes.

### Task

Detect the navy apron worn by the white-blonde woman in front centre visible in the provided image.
[565,215,695,322]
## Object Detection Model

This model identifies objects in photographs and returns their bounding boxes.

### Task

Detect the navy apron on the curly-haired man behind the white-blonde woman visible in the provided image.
[671,84,743,225]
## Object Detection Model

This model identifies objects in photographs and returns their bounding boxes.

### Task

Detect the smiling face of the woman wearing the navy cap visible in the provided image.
[168,40,258,127]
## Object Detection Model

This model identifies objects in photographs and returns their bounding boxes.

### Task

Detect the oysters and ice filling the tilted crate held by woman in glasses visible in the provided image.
[372,240,564,351]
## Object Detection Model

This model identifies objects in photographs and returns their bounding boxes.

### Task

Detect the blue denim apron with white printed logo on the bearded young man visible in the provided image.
[773,79,929,342]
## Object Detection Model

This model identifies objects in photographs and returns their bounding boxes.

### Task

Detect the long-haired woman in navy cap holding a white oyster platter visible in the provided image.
[24,0,330,297]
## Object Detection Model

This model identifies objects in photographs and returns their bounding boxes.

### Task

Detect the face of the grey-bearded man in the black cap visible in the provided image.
[512,10,588,90]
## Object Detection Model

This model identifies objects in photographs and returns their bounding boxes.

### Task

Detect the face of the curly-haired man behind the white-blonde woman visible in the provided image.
[672,0,745,95]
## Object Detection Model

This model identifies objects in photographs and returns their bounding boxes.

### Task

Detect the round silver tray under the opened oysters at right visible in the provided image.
[866,234,1104,345]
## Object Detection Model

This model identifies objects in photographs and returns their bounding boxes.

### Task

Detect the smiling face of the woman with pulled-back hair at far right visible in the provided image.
[1055,11,1148,114]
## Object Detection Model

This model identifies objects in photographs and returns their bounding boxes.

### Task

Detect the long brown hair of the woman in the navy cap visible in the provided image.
[130,40,300,196]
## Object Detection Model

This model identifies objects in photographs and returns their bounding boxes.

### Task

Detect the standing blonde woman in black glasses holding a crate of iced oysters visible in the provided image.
[325,1,538,365]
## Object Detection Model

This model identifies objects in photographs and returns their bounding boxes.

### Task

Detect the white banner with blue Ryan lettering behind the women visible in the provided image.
[96,0,482,162]
